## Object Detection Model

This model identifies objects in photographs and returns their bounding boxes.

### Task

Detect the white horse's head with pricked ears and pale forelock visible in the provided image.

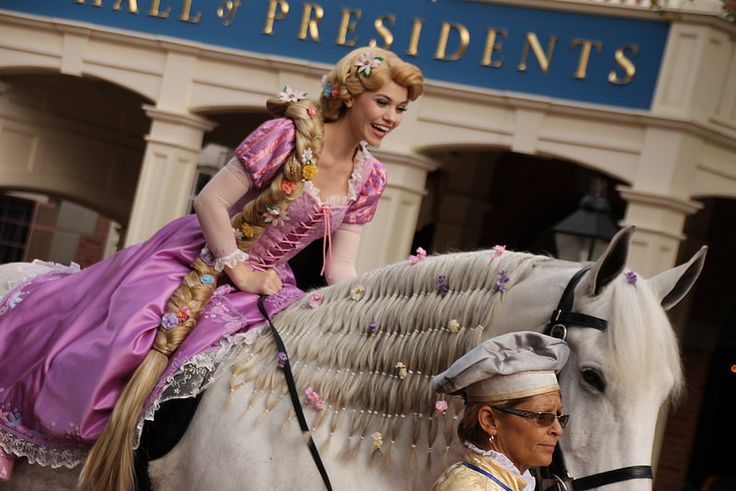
[553,227,706,491]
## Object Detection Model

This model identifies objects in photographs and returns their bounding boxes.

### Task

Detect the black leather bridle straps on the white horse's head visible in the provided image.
[541,268,653,491]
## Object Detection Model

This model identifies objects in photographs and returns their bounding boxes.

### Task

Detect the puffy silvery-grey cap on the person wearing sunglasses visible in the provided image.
[432,331,570,402]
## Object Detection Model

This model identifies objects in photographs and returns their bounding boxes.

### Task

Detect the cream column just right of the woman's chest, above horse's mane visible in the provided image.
[356,150,438,273]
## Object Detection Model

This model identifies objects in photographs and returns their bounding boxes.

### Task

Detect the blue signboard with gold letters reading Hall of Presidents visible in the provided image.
[0,0,669,109]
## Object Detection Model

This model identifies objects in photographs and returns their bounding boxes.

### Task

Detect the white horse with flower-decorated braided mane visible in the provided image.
[0,228,705,491]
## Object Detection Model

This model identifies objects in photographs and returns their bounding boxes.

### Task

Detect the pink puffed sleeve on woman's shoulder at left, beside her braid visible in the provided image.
[235,118,295,189]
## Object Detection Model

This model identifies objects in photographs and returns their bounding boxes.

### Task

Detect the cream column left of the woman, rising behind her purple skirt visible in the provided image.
[125,105,215,246]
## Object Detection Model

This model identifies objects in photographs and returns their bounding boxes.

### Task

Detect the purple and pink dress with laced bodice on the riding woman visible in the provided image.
[0,120,385,467]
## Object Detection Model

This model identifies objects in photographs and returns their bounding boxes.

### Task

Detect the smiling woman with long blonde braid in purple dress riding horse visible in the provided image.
[0,48,423,491]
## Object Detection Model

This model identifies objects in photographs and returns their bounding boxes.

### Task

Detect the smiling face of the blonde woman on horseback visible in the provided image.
[345,81,409,147]
